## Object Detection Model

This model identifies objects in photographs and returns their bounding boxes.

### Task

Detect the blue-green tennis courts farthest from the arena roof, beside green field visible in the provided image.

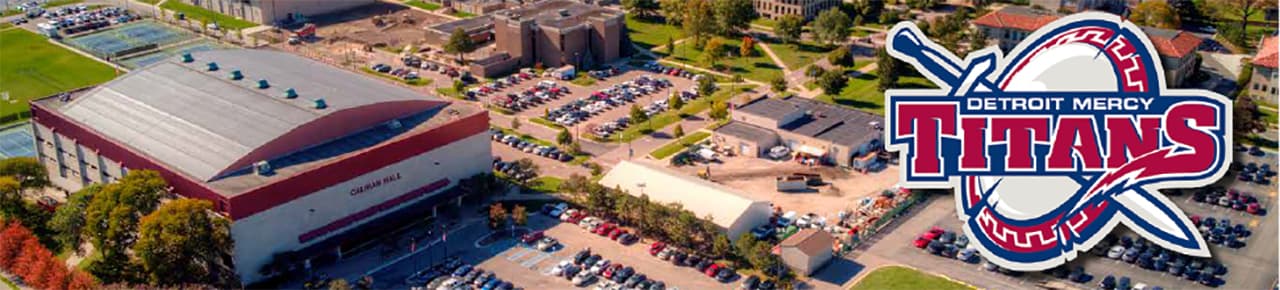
[67,20,196,57]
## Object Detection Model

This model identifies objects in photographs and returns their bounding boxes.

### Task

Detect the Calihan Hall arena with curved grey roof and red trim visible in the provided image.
[31,50,493,284]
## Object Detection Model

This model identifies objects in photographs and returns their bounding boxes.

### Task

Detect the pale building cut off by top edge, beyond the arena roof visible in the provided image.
[182,0,375,26]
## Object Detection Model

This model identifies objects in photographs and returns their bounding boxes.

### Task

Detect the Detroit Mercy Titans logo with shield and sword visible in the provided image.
[884,13,1231,271]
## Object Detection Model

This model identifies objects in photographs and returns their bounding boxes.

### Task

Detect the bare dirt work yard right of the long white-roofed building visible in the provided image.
[660,156,899,220]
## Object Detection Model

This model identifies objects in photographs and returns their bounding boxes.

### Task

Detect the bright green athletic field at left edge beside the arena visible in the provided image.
[0,29,115,116]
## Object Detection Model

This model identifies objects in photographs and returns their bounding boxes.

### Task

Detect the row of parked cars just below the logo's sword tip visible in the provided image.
[1091,235,1228,286]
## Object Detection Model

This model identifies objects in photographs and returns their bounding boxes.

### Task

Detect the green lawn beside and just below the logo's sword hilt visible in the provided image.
[817,70,933,115]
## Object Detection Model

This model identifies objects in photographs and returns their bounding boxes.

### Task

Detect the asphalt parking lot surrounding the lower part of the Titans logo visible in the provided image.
[854,152,1277,289]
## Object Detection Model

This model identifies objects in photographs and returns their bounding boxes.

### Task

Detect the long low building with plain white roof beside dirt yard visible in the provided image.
[600,161,773,240]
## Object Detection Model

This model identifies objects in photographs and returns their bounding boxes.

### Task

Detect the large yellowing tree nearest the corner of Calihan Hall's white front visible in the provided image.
[133,198,239,287]
